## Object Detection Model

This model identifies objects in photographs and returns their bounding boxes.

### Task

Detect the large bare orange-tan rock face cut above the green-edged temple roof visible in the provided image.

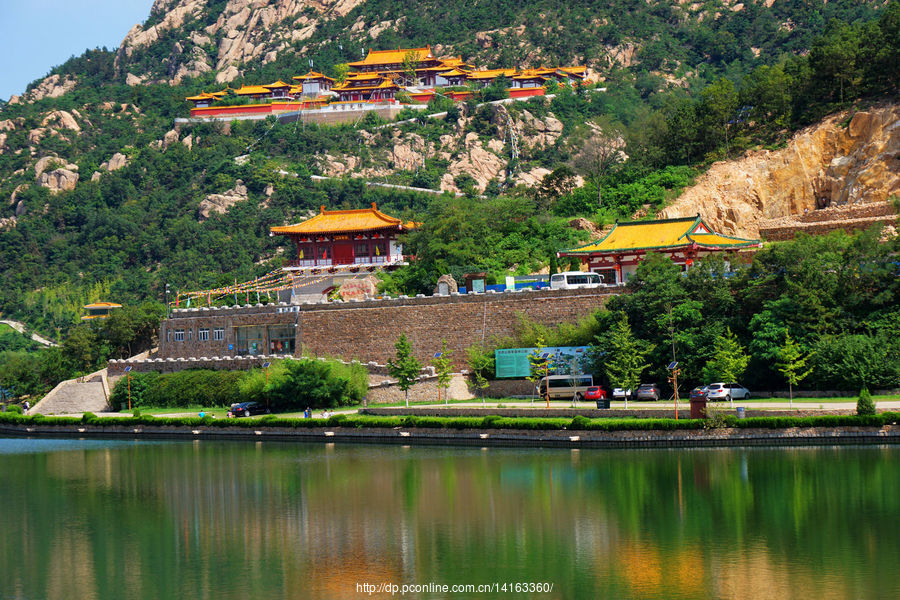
[659,106,900,237]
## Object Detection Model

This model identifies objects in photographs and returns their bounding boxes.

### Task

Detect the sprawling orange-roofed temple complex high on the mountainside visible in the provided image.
[185,46,587,118]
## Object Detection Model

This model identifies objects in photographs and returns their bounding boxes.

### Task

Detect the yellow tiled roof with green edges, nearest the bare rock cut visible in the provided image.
[562,216,759,254]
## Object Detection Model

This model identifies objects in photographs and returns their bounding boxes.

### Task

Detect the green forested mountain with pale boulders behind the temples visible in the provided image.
[0,0,900,331]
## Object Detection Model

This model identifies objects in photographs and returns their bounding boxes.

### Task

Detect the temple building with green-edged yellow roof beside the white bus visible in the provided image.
[557,215,762,284]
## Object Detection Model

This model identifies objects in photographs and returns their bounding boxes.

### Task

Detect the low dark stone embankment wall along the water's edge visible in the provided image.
[0,423,900,448]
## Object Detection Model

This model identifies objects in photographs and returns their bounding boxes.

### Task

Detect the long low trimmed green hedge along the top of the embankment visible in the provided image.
[0,412,900,431]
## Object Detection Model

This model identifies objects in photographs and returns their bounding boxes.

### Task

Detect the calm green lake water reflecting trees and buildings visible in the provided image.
[0,438,900,600]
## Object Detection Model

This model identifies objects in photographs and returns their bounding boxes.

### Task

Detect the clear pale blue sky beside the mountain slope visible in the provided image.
[0,0,153,100]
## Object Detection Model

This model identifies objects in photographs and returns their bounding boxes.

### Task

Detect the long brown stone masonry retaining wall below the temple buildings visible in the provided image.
[151,288,622,368]
